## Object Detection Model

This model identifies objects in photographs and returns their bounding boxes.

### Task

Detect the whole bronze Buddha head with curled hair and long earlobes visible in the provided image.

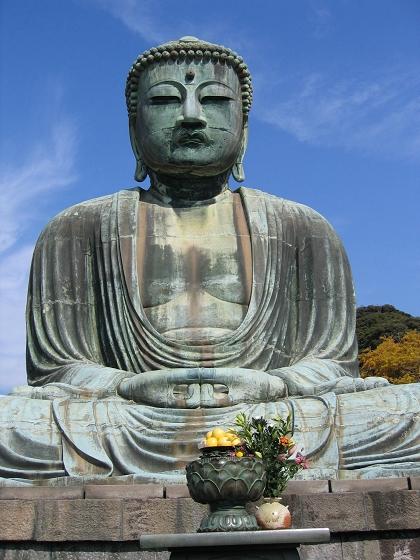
[126,37,252,181]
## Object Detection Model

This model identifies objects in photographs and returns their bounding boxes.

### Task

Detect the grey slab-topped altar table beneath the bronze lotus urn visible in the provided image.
[140,529,330,560]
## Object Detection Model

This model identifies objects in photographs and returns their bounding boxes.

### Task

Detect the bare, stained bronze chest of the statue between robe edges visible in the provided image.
[137,195,252,307]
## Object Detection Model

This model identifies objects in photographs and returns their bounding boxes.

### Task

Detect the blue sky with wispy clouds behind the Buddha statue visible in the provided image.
[0,0,420,388]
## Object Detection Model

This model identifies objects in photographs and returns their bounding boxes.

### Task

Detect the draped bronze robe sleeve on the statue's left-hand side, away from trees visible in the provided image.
[26,203,134,395]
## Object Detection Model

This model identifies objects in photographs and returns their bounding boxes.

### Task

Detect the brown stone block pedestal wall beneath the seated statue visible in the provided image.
[0,477,420,560]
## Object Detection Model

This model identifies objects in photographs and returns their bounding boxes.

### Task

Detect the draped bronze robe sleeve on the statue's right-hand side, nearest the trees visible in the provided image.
[270,206,360,395]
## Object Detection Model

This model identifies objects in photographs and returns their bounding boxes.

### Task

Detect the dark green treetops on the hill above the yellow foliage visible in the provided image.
[356,305,420,352]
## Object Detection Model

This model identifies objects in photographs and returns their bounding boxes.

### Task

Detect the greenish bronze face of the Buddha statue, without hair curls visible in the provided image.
[131,61,243,177]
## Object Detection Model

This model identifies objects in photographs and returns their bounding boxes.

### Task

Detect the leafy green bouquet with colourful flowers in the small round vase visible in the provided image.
[234,413,308,498]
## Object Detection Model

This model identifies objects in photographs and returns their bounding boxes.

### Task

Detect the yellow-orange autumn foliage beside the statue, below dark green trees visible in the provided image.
[359,331,420,384]
